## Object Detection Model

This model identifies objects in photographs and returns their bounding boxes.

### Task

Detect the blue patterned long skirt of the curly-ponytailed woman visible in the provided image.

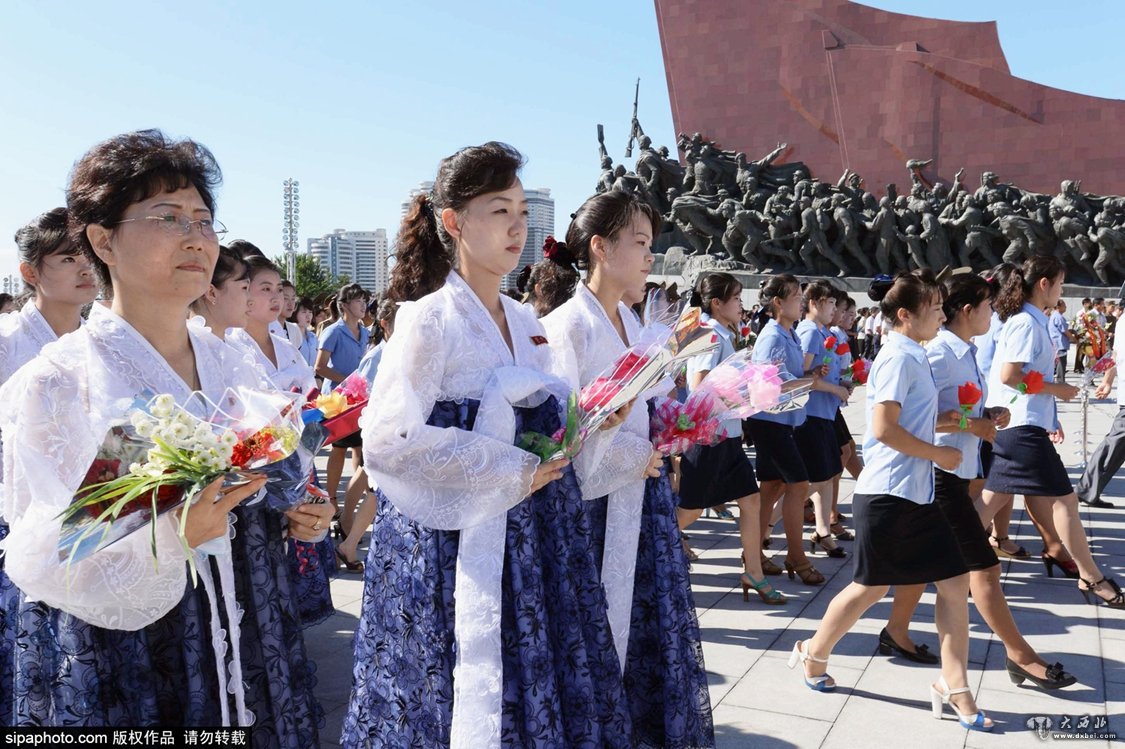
[341,398,633,749]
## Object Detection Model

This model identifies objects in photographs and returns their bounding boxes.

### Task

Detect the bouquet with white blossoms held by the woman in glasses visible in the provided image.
[57,388,300,576]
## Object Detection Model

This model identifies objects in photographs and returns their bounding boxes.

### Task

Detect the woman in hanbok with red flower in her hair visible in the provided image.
[542,191,714,749]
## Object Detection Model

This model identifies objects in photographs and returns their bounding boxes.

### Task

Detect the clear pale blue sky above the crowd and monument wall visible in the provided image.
[0,0,1125,276]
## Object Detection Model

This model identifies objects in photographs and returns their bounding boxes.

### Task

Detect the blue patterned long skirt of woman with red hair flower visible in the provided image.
[624,467,714,749]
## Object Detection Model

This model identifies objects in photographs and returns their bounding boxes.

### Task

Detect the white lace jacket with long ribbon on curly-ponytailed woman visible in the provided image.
[361,272,569,748]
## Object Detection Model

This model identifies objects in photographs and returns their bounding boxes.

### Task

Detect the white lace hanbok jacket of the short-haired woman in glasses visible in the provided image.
[0,305,260,630]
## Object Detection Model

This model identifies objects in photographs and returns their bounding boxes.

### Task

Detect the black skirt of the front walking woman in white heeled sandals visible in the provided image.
[852,494,969,585]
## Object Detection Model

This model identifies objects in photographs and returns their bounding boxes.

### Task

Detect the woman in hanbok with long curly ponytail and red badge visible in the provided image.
[341,143,632,749]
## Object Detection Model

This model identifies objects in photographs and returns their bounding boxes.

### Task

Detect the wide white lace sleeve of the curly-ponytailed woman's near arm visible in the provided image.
[362,303,539,529]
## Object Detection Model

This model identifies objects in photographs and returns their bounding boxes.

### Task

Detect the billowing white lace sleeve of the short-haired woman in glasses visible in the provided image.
[0,361,187,630]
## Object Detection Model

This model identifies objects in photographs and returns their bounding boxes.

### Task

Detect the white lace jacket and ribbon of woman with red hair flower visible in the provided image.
[542,283,657,668]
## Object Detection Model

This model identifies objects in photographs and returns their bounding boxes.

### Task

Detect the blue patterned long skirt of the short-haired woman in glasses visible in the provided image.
[0,507,323,749]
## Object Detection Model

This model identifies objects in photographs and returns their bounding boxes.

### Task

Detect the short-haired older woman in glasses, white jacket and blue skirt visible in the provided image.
[0,130,339,747]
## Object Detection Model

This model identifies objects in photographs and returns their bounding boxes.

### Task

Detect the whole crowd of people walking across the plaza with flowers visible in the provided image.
[0,130,1125,749]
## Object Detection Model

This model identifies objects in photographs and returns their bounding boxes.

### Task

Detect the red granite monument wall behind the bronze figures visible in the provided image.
[655,0,1125,195]
